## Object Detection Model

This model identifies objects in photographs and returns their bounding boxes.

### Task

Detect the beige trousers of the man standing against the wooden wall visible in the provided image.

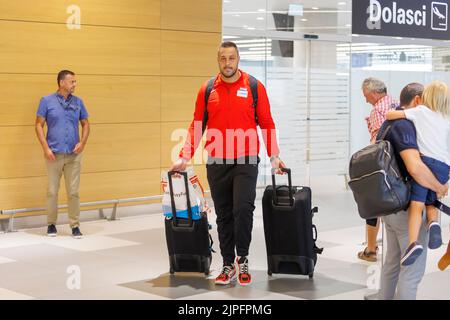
[46,153,82,228]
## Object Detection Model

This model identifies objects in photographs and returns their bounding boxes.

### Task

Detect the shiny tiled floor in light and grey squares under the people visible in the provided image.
[0,180,450,300]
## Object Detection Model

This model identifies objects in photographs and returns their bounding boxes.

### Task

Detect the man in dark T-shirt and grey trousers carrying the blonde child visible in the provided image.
[366,83,448,300]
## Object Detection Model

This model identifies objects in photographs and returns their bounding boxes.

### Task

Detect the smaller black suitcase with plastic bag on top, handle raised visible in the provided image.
[165,172,212,275]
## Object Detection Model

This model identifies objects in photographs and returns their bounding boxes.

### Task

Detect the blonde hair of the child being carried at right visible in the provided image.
[422,81,450,116]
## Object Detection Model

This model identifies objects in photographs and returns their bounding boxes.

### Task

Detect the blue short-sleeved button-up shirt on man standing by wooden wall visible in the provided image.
[37,93,89,154]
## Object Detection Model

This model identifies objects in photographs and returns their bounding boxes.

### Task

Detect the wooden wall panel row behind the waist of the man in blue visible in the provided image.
[0,123,160,178]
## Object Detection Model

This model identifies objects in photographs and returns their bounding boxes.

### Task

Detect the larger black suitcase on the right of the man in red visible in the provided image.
[262,169,323,278]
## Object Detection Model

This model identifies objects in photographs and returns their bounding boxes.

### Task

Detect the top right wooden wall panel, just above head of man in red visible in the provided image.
[161,0,222,33]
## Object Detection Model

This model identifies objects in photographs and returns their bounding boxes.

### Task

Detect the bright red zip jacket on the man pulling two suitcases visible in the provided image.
[179,70,279,160]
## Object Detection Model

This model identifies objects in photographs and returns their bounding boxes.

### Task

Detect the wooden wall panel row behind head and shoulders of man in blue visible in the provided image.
[0,74,161,126]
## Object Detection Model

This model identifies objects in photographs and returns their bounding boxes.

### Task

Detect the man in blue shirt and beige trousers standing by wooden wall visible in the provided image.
[36,70,89,239]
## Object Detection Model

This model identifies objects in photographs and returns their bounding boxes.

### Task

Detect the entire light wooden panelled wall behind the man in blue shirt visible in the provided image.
[0,0,222,209]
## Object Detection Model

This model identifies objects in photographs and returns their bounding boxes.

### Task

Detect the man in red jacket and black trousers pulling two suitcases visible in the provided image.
[171,42,285,285]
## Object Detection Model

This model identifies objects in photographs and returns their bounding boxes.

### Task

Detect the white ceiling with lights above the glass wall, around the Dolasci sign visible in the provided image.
[222,0,450,47]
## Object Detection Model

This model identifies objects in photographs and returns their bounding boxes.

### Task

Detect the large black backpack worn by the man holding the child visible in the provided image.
[348,126,411,219]
